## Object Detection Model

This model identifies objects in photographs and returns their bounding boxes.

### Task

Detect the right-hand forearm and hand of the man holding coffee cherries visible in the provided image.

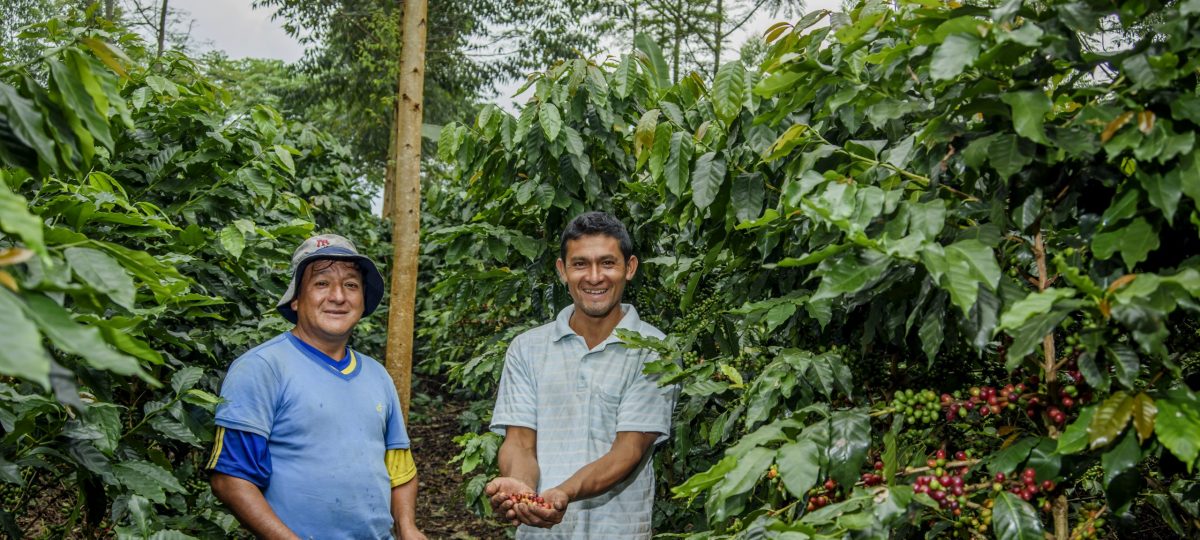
[515,431,659,528]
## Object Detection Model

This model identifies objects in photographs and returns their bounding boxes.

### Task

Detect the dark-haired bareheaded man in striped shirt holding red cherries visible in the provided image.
[486,212,678,539]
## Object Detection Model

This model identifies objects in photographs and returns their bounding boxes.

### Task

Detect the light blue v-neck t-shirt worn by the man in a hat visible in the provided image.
[216,332,409,539]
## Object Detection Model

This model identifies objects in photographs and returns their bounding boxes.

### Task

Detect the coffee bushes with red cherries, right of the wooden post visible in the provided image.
[436,0,1200,539]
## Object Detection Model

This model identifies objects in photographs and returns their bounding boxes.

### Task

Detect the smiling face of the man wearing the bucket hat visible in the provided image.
[292,260,362,341]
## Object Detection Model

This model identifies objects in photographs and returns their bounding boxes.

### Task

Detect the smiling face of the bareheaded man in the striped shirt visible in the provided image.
[557,234,637,318]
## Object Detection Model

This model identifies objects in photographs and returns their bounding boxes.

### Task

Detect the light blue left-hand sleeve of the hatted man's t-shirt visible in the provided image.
[216,355,280,438]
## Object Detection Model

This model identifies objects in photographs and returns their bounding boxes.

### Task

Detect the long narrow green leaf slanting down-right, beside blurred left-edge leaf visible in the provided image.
[24,294,157,385]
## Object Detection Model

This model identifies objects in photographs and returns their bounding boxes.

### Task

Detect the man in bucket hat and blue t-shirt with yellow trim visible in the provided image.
[208,234,425,540]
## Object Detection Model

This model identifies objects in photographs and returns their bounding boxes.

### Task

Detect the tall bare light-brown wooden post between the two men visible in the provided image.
[386,0,428,420]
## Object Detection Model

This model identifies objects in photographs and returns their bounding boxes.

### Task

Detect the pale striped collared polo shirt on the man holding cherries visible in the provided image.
[491,304,678,539]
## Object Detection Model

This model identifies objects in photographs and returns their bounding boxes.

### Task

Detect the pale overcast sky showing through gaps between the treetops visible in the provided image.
[170,0,841,112]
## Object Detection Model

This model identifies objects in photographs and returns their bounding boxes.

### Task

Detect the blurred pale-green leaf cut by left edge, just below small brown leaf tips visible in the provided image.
[0,288,50,390]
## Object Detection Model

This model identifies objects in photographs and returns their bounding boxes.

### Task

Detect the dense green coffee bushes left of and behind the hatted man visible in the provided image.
[0,8,386,539]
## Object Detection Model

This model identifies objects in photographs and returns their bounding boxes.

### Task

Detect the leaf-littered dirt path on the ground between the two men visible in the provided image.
[408,401,508,540]
